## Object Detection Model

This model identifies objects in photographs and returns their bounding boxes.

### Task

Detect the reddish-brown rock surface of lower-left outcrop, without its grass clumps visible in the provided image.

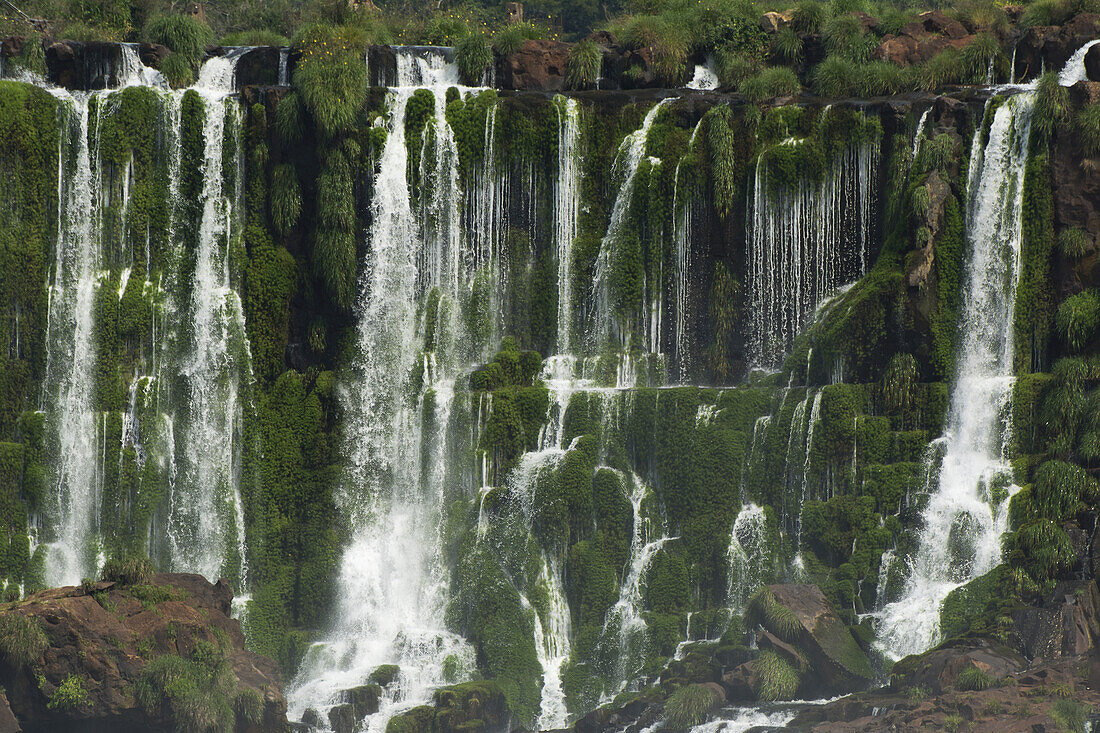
[0,573,286,733]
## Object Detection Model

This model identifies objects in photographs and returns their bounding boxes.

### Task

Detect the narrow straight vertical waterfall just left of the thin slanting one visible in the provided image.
[553,96,581,354]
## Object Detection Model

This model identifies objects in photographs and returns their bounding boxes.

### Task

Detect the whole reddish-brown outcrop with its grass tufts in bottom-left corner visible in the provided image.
[0,573,286,733]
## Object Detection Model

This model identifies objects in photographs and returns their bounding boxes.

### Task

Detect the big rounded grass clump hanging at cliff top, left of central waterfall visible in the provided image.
[292,23,367,136]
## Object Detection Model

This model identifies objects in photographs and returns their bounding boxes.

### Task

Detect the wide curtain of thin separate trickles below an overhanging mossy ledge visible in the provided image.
[746,129,879,369]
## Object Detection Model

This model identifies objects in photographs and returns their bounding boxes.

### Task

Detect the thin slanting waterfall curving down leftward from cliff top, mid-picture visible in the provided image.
[592,98,672,349]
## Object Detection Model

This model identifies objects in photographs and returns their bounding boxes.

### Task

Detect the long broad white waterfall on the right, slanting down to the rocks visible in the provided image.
[877,91,1034,658]
